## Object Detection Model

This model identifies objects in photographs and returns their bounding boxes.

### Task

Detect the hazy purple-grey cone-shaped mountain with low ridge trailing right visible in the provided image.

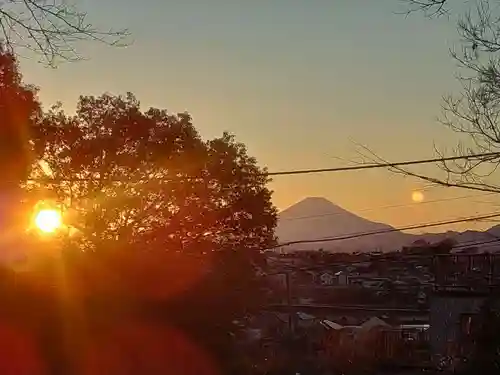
[276,197,500,252]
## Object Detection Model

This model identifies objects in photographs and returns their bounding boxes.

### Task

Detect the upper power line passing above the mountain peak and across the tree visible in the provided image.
[28,152,500,183]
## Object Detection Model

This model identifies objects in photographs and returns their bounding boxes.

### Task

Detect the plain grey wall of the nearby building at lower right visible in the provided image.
[429,295,485,360]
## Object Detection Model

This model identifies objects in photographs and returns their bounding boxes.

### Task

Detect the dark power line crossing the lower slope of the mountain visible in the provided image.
[267,212,500,250]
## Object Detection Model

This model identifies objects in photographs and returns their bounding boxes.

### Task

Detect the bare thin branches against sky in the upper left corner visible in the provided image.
[0,0,128,66]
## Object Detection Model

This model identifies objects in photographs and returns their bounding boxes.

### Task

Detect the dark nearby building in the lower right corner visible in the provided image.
[429,254,500,370]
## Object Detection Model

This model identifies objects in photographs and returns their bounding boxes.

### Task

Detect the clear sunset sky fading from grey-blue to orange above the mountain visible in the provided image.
[17,0,498,234]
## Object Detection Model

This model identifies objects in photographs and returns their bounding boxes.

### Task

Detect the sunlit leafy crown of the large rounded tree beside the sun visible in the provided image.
[29,94,276,254]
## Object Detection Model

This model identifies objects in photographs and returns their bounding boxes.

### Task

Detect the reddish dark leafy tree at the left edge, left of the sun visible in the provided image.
[0,48,58,374]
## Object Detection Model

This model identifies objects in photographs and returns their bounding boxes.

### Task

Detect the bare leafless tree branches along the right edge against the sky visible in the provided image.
[370,0,500,197]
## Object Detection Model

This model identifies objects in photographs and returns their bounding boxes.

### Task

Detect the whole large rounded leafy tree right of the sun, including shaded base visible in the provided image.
[24,94,276,374]
